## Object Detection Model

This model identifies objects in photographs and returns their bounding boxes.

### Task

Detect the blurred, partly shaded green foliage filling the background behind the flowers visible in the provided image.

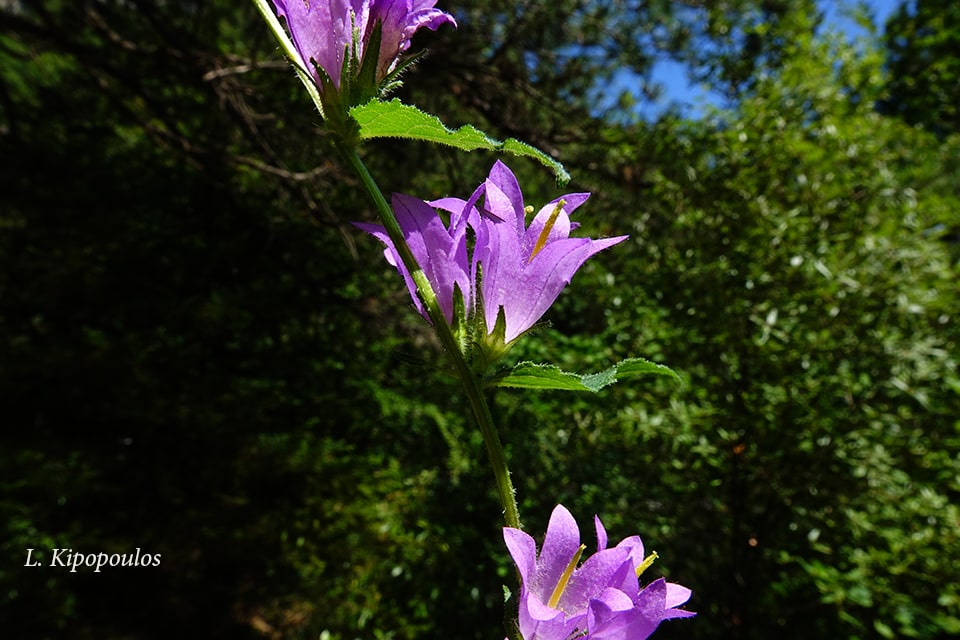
[0,0,960,640]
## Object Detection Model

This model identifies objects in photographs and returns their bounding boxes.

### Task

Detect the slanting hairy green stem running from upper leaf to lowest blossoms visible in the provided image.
[341,148,521,529]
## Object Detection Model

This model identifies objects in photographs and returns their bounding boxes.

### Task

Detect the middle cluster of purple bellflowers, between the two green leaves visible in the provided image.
[357,160,627,364]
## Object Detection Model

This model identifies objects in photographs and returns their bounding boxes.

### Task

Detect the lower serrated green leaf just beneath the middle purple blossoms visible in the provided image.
[488,358,680,393]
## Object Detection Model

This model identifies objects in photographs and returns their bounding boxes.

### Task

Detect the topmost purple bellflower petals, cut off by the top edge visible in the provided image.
[273,0,457,89]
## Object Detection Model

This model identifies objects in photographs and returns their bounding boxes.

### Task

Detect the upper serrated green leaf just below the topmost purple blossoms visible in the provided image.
[350,99,570,186]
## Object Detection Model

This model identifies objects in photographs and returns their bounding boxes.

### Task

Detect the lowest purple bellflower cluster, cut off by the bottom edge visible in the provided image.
[503,505,694,640]
